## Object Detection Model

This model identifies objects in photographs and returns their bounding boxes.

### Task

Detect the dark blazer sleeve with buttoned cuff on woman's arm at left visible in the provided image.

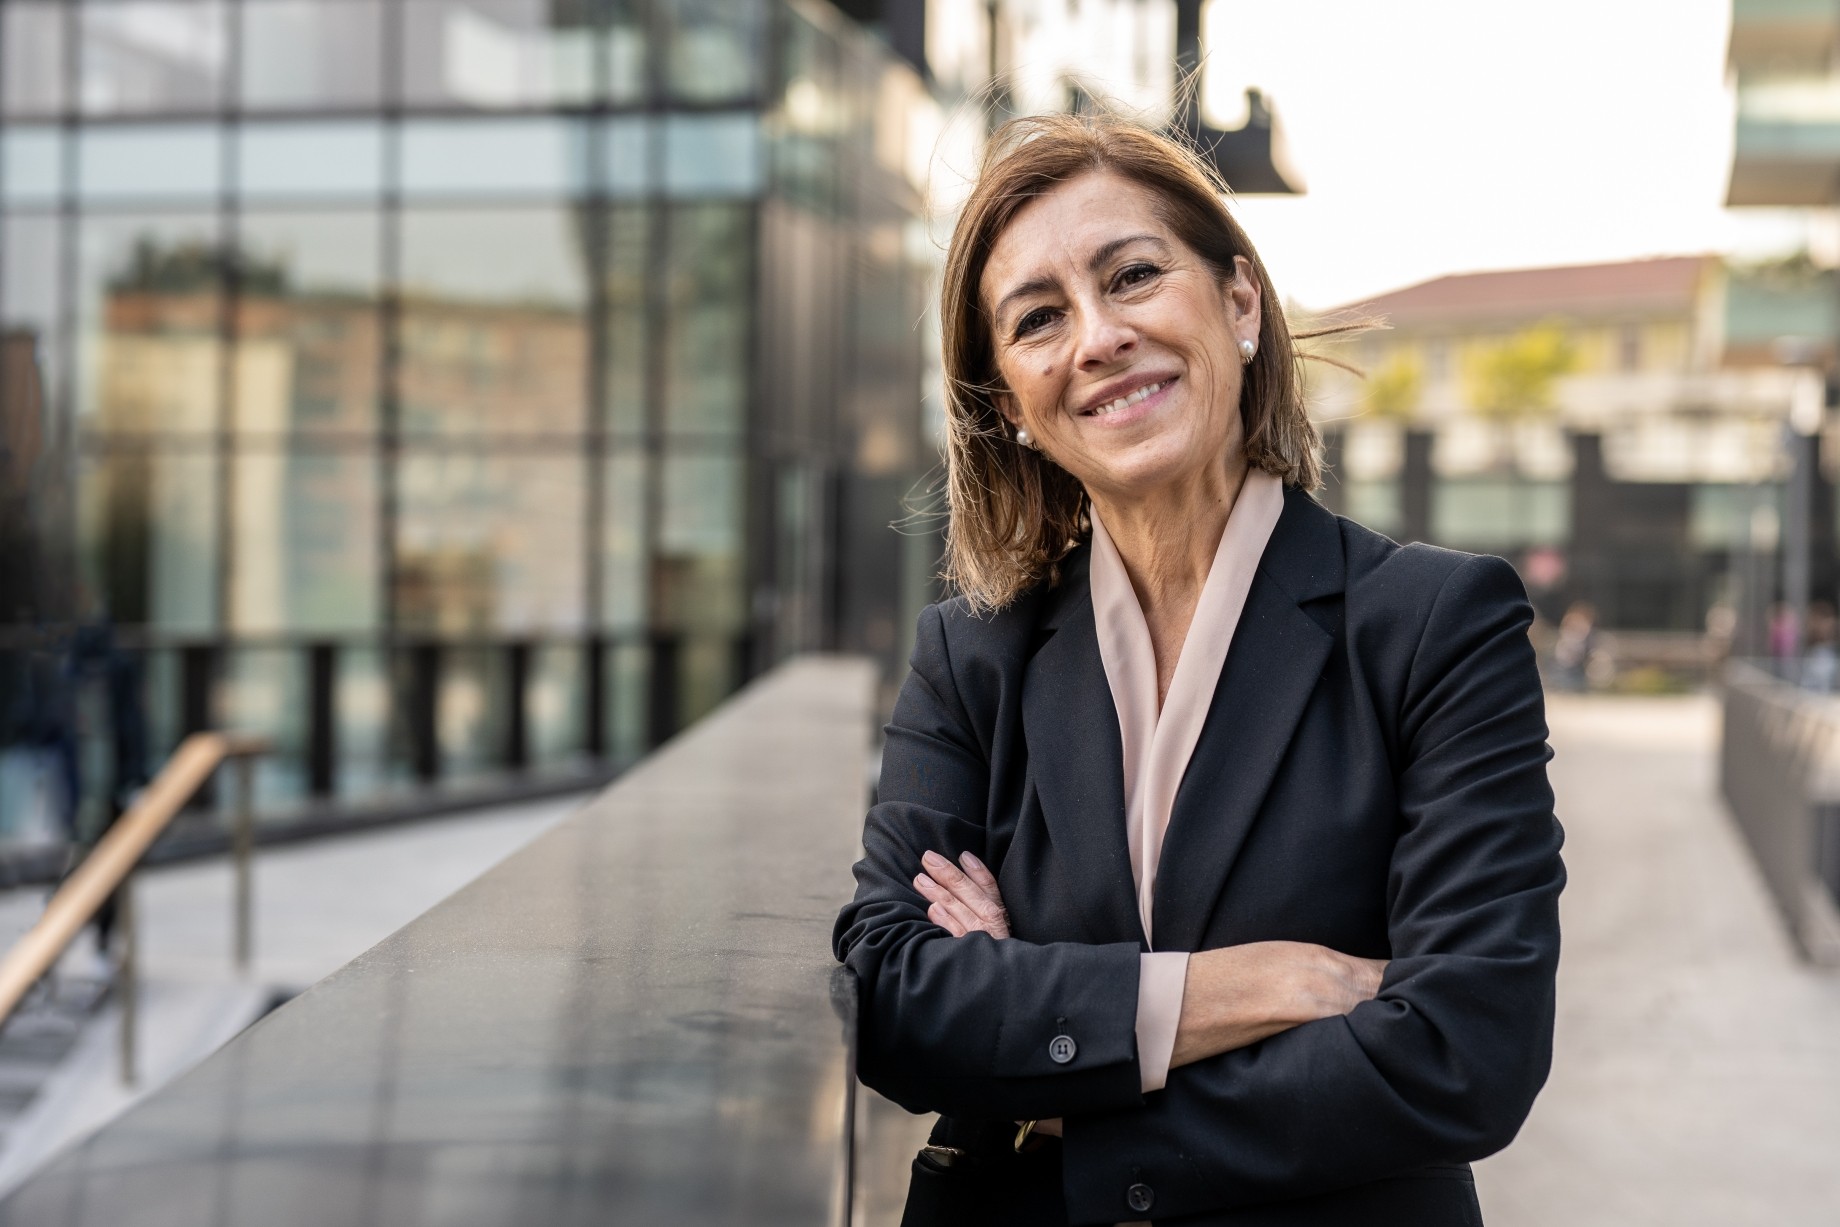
[834,605,1143,1120]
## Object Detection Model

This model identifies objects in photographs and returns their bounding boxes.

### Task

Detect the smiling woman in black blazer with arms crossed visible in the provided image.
[837,116,1564,1227]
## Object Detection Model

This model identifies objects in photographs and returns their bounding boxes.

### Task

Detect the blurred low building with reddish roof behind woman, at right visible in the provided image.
[1316,256,1834,631]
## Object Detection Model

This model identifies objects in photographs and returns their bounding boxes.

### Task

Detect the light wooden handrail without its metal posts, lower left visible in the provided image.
[0,732,269,1023]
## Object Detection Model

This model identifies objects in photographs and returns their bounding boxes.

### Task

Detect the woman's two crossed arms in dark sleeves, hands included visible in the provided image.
[837,559,1564,1221]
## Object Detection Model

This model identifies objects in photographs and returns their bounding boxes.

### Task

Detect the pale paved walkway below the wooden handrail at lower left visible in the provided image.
[0,795,587,1192]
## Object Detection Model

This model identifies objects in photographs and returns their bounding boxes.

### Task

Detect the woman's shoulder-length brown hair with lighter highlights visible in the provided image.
[940,114,1341,609]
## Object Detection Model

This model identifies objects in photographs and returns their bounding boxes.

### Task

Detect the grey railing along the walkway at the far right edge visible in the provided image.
[1719,660,1840,966]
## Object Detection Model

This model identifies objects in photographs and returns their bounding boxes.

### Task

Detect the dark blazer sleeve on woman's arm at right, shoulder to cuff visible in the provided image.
[1064,557,1564,1223]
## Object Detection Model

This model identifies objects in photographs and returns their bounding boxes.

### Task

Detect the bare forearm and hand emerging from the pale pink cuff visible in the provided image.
[1170,942,1386,1067]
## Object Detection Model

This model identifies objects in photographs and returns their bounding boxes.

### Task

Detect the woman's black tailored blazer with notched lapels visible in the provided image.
[835,489,1564,1227]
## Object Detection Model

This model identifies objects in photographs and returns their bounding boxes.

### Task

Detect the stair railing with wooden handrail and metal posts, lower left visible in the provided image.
[0,732,269,1085]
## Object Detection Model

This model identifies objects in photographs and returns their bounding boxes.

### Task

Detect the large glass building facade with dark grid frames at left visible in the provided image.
[0,0,937,835]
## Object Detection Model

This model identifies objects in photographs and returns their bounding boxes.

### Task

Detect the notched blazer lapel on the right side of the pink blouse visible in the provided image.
[1155,489,1343,951]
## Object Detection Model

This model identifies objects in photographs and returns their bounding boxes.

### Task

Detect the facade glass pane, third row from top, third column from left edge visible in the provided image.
[234,212,383,434]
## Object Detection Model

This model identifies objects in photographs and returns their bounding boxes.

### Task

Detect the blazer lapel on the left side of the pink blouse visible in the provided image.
[1023,546,1144,946]
